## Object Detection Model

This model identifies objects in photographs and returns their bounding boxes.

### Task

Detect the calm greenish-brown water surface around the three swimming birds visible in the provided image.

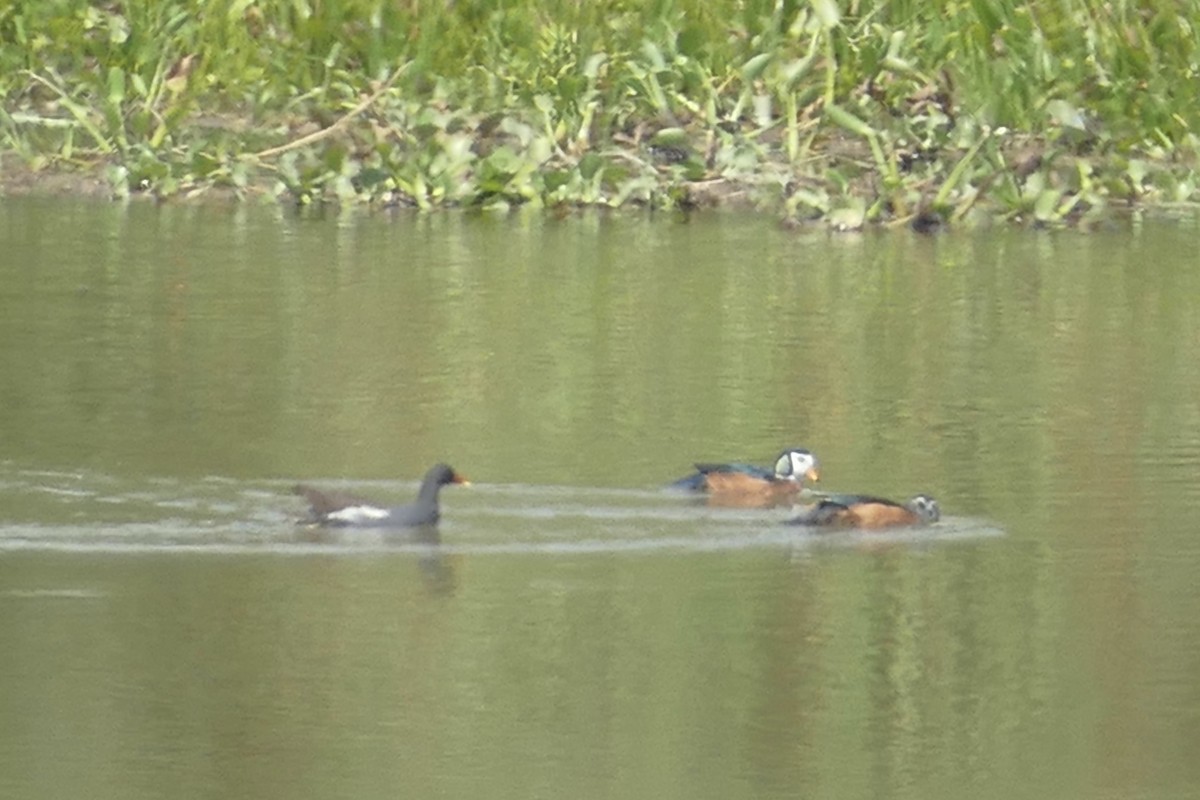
[0,199,1200,800]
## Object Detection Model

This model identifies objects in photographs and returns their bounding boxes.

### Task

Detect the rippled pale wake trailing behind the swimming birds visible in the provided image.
[0,471,1002,557]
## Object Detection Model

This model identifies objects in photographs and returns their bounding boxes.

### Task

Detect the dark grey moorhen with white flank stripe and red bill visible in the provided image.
[294,464,470,528]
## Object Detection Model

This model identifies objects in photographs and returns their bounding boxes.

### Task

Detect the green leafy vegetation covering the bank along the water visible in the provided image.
[0,0,1200,228]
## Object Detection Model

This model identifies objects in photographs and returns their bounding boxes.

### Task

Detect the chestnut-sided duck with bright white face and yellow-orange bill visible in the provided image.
[670,447,821,507]
